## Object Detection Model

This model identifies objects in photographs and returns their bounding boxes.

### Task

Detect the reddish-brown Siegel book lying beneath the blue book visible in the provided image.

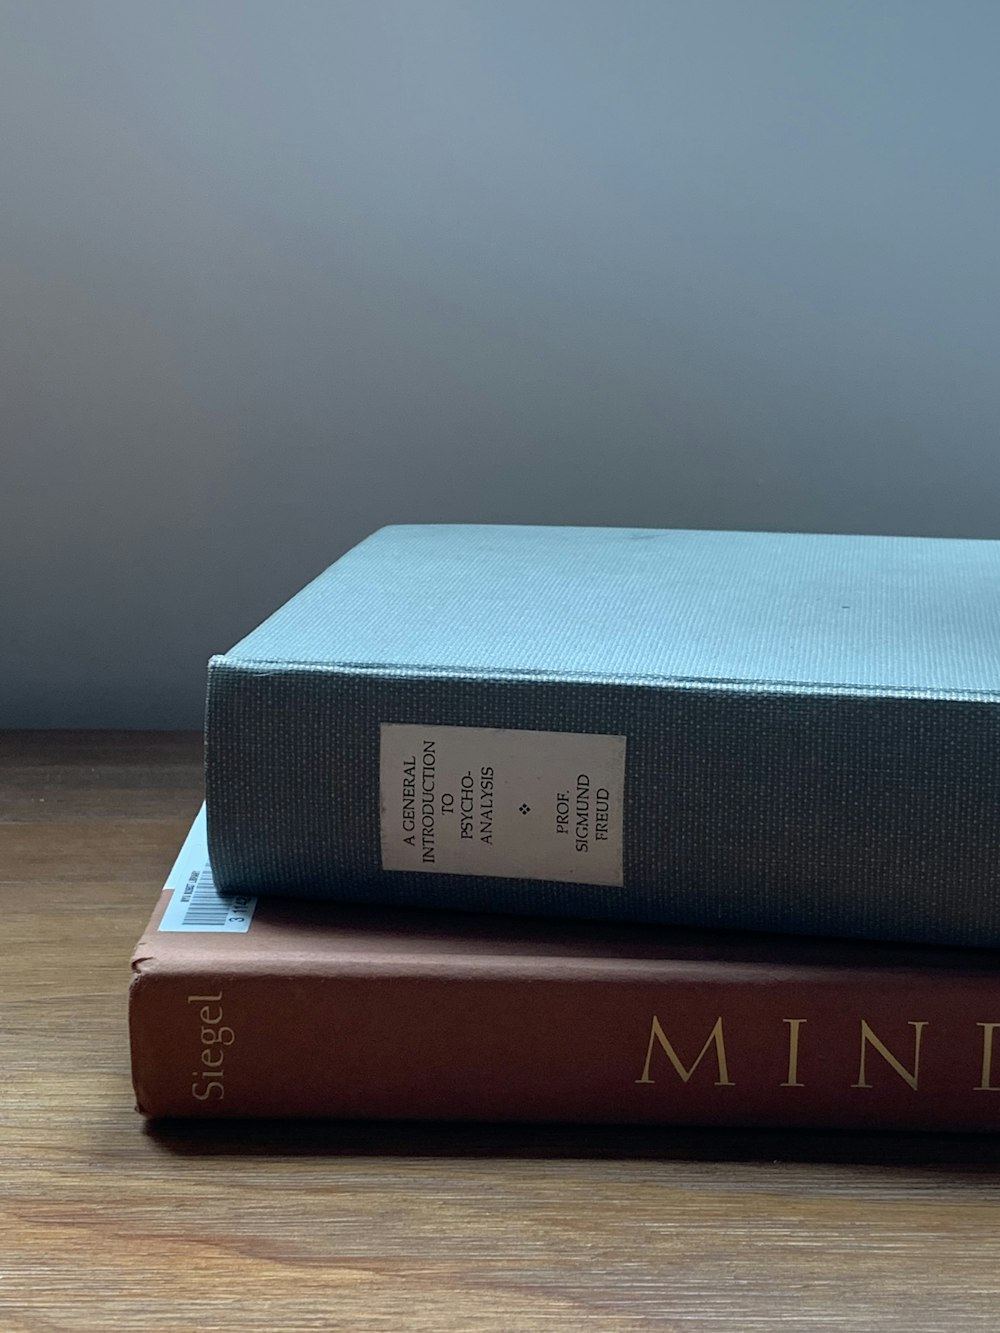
[129,821,1000,1130]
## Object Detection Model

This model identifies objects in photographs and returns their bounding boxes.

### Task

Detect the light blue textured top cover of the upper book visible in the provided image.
[227,525,1000,697]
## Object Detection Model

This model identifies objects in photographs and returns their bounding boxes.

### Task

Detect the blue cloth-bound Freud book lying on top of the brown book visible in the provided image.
[205,525,1000,946]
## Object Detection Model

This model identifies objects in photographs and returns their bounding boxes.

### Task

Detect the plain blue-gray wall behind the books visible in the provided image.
[0,0,1000,728]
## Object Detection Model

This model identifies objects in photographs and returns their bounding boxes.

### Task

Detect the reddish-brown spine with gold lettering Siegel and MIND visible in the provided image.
[129,960,1000,1130]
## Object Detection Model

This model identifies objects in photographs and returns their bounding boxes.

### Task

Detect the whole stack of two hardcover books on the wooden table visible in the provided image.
[129,527,1000,1130]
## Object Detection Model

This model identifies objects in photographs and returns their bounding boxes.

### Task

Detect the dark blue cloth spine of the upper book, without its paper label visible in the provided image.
[207,659,1000,946]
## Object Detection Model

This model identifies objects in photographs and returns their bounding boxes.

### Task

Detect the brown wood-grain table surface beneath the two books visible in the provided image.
[0,732,1000,1333]
